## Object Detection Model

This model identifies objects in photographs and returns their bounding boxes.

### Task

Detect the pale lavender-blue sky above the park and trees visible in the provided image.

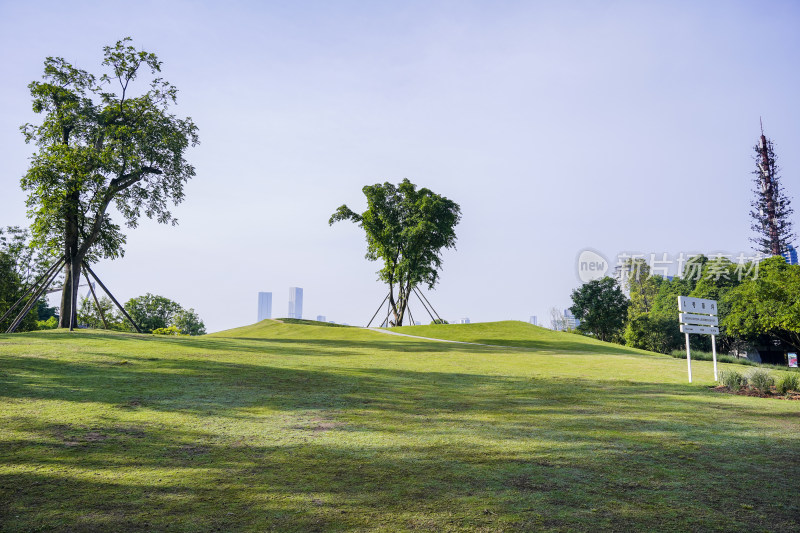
[0,0,800,331]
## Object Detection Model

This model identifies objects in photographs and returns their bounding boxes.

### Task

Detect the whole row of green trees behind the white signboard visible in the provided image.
[570,255,800,353]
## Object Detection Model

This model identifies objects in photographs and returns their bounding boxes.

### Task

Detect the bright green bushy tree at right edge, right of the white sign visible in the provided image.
[720,256,800,350]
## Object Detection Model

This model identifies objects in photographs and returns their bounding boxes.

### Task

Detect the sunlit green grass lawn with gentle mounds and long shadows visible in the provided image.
[0,321,800,532]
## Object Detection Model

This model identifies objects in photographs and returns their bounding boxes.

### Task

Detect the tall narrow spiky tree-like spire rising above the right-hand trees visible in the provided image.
[750,130,795,255]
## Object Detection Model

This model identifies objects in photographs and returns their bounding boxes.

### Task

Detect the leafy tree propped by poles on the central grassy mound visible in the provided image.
[328,179,461,326]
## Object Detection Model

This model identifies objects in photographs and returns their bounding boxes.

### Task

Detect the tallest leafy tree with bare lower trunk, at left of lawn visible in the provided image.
[22,38,198,327]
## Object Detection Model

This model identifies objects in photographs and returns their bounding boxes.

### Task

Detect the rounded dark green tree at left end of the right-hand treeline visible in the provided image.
[569,276,628,341]
